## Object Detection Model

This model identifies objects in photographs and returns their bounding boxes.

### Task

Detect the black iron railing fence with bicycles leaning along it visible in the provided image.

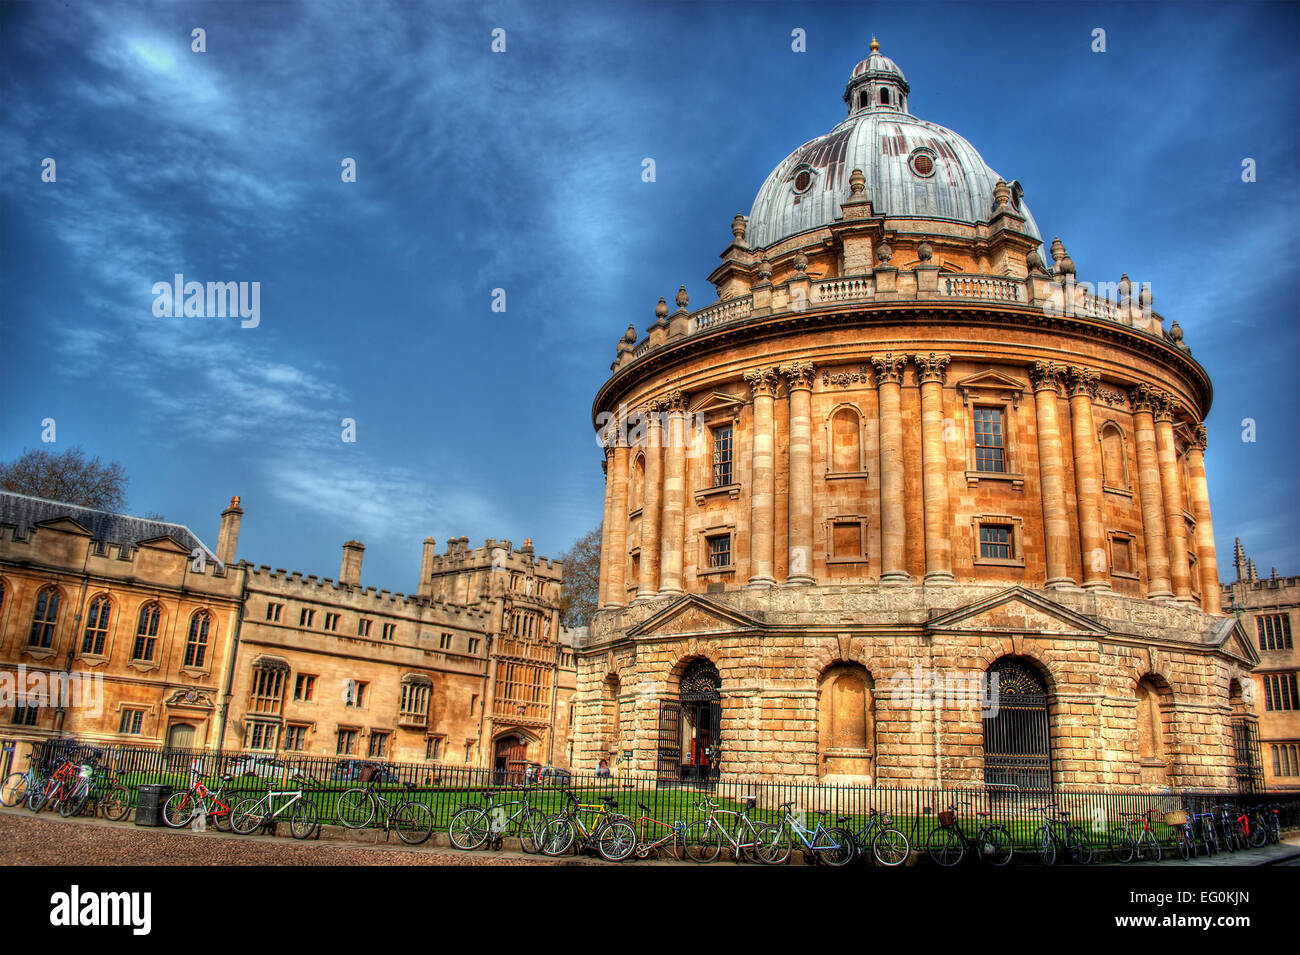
[16,739,1300,850]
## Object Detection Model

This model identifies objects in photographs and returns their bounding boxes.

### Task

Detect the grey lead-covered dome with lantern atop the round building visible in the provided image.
[745,40,1041,248]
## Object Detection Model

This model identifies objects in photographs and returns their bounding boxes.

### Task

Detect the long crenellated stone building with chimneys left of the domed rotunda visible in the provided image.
[0,494,575,773]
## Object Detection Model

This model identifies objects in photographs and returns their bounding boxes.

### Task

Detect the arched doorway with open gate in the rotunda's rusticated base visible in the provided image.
[659,659,723,782]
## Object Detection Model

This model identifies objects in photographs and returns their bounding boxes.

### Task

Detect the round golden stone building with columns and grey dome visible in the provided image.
[573,40,1257,790]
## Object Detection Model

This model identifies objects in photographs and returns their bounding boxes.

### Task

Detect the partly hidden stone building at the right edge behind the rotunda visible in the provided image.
[1222,538,1300,790]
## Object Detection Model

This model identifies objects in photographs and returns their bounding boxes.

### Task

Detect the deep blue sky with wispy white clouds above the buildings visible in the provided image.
[0,1,1300,590]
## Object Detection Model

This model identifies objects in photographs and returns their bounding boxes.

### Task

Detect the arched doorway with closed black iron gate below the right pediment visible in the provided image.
[983,656,1052,791]
